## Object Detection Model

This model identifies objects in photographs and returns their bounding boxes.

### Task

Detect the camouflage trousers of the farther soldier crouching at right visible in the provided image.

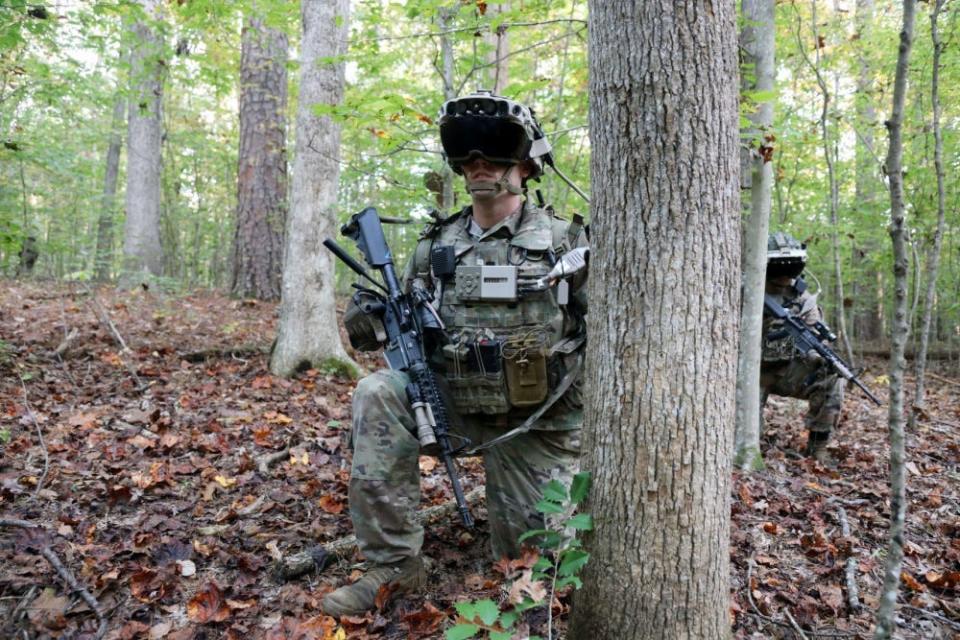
[760,358,846,434]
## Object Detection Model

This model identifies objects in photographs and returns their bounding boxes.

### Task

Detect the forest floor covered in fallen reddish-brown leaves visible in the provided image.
[0,281,960,640]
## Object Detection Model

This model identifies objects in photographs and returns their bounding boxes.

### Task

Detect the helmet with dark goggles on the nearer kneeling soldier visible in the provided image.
[439,90,552,179]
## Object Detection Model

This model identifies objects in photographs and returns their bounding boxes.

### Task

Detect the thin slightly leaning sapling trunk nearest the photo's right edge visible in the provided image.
[910,0,947,424]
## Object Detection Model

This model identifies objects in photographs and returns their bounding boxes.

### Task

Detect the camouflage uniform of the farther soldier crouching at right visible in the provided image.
[760,285,844,440]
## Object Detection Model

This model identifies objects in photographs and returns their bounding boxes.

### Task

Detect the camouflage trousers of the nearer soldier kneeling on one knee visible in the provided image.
[349,369,580,563]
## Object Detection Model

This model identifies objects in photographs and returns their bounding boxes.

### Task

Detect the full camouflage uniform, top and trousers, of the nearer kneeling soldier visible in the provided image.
[349,204,586,564]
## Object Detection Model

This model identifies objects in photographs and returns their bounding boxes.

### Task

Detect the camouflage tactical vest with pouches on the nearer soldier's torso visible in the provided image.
[408,205,583,415]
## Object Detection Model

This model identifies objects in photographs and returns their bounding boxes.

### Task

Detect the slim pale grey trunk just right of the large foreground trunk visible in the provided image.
[734,0,776,470]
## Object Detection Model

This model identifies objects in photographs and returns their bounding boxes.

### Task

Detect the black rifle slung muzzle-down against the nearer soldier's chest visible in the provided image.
[323,207,473,528]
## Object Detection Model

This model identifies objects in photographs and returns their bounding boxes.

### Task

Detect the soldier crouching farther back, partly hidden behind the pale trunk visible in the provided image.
[760,232,845,462]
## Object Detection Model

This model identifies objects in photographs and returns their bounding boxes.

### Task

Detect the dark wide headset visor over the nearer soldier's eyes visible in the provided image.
[440,115,530,166]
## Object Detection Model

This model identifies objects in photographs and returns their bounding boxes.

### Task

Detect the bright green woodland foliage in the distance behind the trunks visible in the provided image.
[0,0,960,360]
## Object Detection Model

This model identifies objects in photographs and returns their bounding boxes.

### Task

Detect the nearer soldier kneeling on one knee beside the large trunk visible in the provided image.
[322,92,586,616]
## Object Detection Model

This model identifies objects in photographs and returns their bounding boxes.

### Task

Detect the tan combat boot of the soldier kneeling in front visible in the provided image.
[320,556,427,616]
